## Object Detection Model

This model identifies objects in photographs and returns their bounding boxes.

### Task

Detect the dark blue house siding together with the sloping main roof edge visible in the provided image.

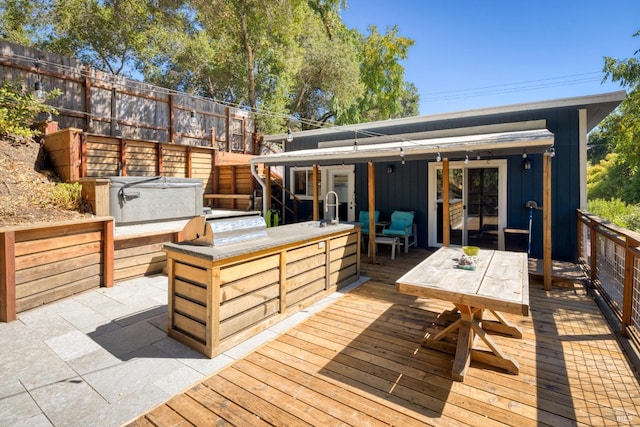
[272,91,625,261]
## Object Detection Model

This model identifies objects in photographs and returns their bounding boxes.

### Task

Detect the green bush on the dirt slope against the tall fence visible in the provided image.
[0,80,60,138]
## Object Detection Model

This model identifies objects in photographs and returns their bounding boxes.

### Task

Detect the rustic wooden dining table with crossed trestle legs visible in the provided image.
[396,247,529,381]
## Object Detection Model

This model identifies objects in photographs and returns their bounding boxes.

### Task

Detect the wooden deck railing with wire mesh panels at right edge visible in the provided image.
[577,210,640,348]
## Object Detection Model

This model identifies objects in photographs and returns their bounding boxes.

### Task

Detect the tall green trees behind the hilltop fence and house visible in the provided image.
[0,0,419,133]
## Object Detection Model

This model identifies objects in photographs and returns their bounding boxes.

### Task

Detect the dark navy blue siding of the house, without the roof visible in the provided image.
[287,108,580,261]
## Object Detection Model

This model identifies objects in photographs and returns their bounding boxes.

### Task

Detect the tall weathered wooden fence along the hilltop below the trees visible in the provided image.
[0,41,257,150]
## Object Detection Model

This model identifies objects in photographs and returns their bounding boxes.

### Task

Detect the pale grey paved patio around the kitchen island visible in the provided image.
[0,275,362,426]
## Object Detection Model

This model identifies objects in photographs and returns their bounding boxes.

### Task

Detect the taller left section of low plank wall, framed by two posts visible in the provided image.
[0,218,114,322]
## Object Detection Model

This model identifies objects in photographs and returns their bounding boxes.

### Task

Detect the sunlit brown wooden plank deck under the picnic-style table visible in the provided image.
[130,249,640,427]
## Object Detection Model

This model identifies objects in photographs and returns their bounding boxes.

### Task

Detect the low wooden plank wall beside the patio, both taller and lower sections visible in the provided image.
[0,217,190,322]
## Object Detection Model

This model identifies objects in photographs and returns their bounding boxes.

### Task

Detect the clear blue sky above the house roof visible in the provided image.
[342,0,640,115]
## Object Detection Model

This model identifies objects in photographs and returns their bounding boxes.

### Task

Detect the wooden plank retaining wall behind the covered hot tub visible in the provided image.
[44,128,256,215]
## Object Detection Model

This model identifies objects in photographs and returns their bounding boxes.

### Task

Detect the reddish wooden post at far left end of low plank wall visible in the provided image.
[0,231,16,322]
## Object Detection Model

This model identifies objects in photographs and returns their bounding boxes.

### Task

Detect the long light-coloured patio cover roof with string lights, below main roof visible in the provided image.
[250,129,554,166]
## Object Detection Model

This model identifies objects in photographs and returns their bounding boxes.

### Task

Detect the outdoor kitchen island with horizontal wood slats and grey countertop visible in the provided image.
[164,221,360,357]
